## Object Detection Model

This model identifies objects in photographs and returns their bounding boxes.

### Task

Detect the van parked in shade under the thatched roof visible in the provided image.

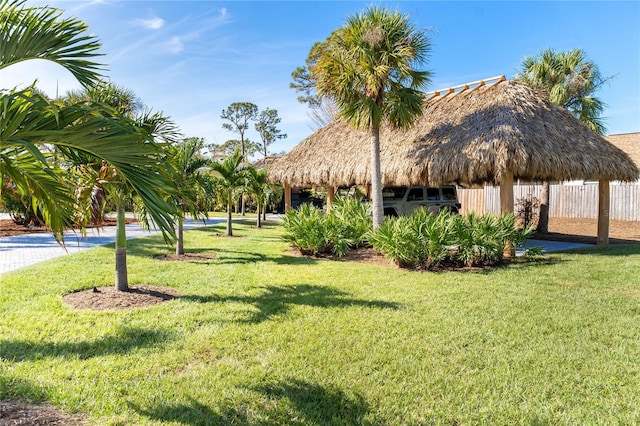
[382,185,462,216]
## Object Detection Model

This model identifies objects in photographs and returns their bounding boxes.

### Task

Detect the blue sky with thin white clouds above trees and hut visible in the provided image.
[5,0,640,156]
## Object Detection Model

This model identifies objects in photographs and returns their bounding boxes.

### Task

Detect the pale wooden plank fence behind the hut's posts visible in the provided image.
[458,183,640,221]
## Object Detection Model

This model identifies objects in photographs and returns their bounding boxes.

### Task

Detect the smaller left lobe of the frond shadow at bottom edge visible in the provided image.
[129,398,249,426]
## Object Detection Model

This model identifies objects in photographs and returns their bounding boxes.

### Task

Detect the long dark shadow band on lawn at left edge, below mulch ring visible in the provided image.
[0,327,169,362]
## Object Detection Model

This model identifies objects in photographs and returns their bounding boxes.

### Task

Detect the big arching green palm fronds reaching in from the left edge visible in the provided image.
[0,0,178,246]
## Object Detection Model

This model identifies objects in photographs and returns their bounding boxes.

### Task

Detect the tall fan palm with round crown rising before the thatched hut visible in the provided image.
[310,6,431,228]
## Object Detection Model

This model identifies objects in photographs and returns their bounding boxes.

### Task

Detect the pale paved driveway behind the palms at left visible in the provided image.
[0,218,220,274]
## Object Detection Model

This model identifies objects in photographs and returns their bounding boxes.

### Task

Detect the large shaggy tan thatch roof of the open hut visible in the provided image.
[269,77,639,186]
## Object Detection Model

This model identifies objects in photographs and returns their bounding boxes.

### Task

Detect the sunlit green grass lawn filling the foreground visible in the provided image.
[0,220,640,425]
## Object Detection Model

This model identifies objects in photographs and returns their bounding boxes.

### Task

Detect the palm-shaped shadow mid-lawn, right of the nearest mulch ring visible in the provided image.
[180,284,399,323]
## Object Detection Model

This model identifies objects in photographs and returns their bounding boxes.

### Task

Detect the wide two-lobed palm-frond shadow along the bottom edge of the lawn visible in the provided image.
[129,379,371,426]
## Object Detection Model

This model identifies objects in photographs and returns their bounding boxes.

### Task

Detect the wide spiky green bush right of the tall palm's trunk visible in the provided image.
[368,209,533,269]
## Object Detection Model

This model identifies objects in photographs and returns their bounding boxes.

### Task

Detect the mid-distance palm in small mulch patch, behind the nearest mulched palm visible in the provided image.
[169,137,211,255]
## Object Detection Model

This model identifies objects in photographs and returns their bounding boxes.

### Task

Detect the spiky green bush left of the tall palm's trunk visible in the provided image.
[283,197,372,256]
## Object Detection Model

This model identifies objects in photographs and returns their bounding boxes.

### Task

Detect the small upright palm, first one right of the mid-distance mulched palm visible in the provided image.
[211,150,249,237]
